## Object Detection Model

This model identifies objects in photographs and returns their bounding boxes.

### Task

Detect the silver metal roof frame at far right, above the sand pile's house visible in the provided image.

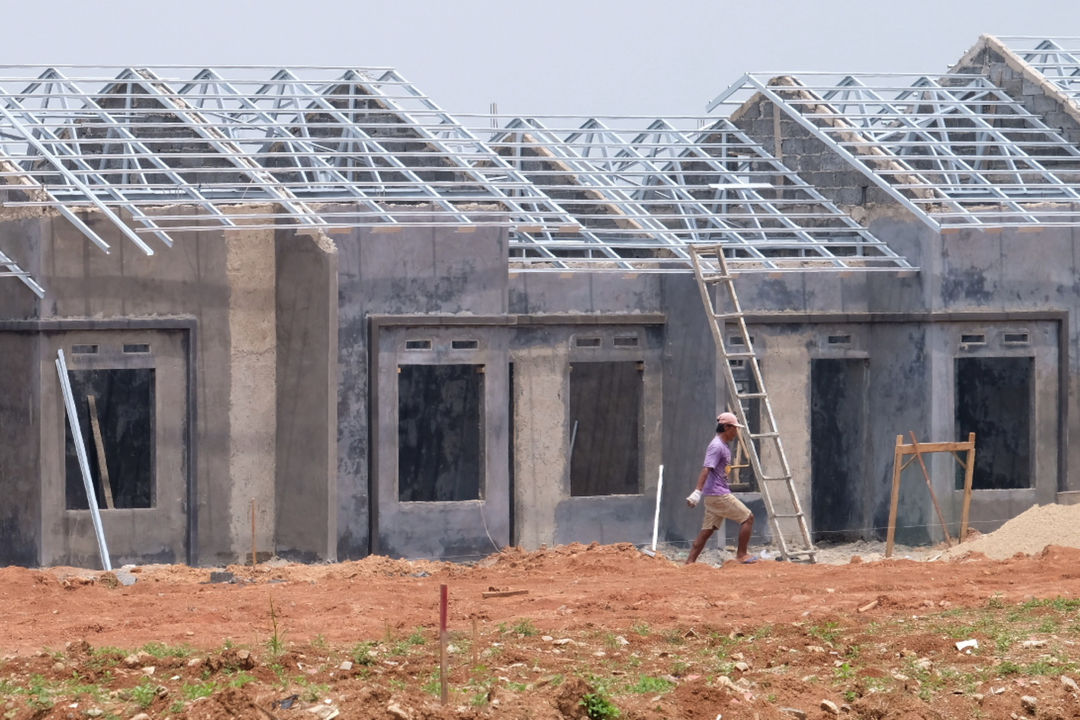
[708,73,1080,230]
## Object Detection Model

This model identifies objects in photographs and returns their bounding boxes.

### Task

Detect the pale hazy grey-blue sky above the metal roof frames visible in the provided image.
[8,0,1080,116]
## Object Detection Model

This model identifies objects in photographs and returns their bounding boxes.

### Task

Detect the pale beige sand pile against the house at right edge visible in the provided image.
[942,505,1080,560]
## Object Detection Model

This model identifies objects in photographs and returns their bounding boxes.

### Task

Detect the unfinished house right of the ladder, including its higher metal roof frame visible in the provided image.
[713,39,1080,542]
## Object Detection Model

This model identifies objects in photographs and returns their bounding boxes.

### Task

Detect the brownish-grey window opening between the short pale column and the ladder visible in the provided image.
[569,362,643,497]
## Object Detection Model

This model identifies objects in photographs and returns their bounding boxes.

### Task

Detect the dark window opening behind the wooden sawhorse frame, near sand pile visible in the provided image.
[956,357,1035,490]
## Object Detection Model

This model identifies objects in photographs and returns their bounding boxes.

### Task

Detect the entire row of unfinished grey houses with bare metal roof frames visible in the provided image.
[0,39,1080,566]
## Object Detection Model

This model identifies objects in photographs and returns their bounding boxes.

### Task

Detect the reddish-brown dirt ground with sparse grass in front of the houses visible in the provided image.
[0,518,1080,720]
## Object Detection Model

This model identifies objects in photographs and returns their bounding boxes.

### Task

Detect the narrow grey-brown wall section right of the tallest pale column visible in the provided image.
[274,230,338,561]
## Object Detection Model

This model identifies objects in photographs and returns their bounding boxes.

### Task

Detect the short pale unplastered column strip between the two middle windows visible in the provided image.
[511,347,569,549]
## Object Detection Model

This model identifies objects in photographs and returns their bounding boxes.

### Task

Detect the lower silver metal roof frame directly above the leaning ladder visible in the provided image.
[490,117,912,271]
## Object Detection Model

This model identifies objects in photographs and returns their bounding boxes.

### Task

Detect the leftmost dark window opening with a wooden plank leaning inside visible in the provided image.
[64,368,156,510]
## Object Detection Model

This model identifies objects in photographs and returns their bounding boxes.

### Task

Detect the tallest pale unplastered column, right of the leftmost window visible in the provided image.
[224,229,278,558]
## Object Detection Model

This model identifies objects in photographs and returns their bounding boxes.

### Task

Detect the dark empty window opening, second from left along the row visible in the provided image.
[397,365,484,502]
